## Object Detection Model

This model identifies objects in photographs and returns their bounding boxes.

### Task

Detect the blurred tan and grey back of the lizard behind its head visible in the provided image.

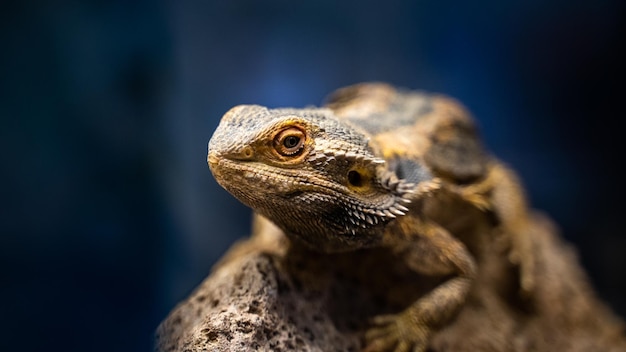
[325,83,489,183]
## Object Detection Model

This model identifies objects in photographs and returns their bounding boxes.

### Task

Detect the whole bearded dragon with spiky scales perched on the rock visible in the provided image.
[207,82,533,352]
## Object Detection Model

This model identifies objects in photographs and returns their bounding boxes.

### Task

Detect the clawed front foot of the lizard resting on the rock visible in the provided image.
[363,314,430,352]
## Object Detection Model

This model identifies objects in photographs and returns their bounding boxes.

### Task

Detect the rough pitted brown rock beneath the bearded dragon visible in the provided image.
[155,215,626,352]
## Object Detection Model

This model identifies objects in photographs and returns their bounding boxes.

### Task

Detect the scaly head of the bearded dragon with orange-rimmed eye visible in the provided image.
[207,105,413,252]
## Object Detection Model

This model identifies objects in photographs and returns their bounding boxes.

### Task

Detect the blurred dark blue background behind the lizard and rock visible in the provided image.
[0,0,626,351]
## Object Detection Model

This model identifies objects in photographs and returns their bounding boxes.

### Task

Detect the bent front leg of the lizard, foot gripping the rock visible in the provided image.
[365,218,476,352]
